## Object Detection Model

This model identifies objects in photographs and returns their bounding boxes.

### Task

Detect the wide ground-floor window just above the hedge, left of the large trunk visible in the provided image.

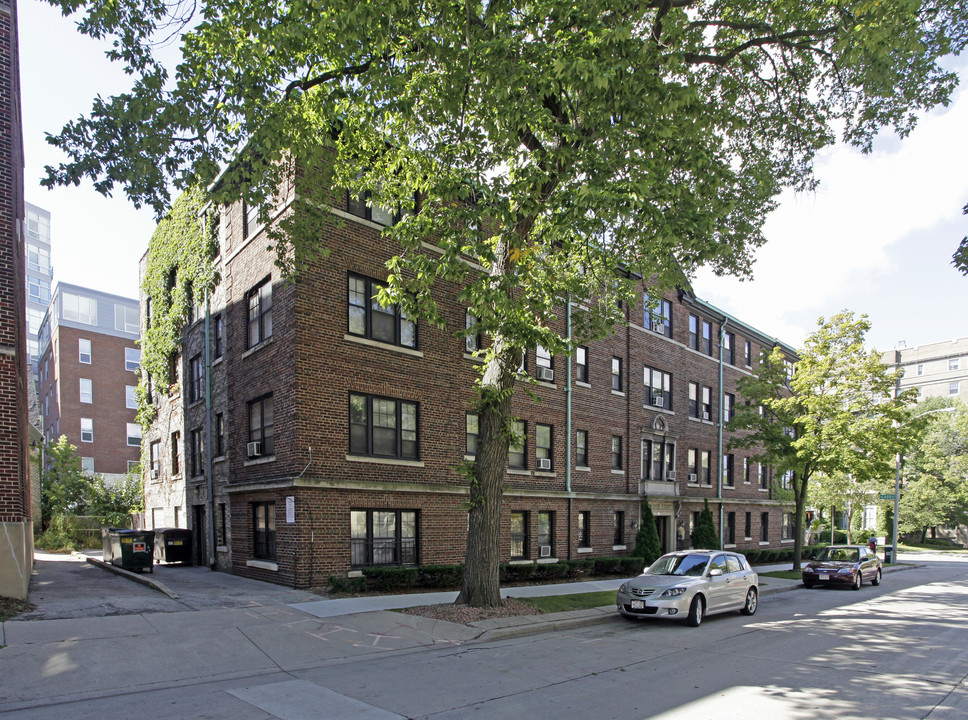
[350,510,418,567]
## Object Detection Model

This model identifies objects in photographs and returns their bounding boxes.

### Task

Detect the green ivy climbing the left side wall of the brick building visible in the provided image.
[138,189,218,431]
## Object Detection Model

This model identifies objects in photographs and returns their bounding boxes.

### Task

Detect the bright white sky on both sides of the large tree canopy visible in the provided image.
[18,0,968,350]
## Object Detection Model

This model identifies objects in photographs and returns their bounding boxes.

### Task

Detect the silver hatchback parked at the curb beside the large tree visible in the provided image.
[615,550,759,627]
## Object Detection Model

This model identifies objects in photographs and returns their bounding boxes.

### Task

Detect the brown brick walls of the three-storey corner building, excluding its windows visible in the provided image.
[142,183,789,587]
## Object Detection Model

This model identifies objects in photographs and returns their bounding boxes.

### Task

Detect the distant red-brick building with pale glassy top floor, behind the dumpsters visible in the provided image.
[38,283,141,483]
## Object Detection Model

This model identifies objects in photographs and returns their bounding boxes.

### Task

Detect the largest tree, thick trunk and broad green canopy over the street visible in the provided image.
[45,0,968,605]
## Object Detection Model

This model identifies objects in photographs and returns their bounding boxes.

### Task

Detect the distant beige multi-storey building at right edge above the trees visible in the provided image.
[883,337,968,401]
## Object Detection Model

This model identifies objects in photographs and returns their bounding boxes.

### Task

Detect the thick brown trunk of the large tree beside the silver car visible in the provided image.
[456,336,521,607]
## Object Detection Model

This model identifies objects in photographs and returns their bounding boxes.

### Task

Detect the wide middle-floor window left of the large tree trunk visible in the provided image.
[350,393,417,460]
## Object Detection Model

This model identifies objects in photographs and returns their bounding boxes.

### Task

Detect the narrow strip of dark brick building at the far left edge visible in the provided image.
[0,0,34,599]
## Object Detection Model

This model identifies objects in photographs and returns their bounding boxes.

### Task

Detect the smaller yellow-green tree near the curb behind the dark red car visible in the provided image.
[729,311,911,570]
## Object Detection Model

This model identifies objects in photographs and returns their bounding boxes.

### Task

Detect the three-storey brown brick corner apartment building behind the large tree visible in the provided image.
[141,181,793,587]
